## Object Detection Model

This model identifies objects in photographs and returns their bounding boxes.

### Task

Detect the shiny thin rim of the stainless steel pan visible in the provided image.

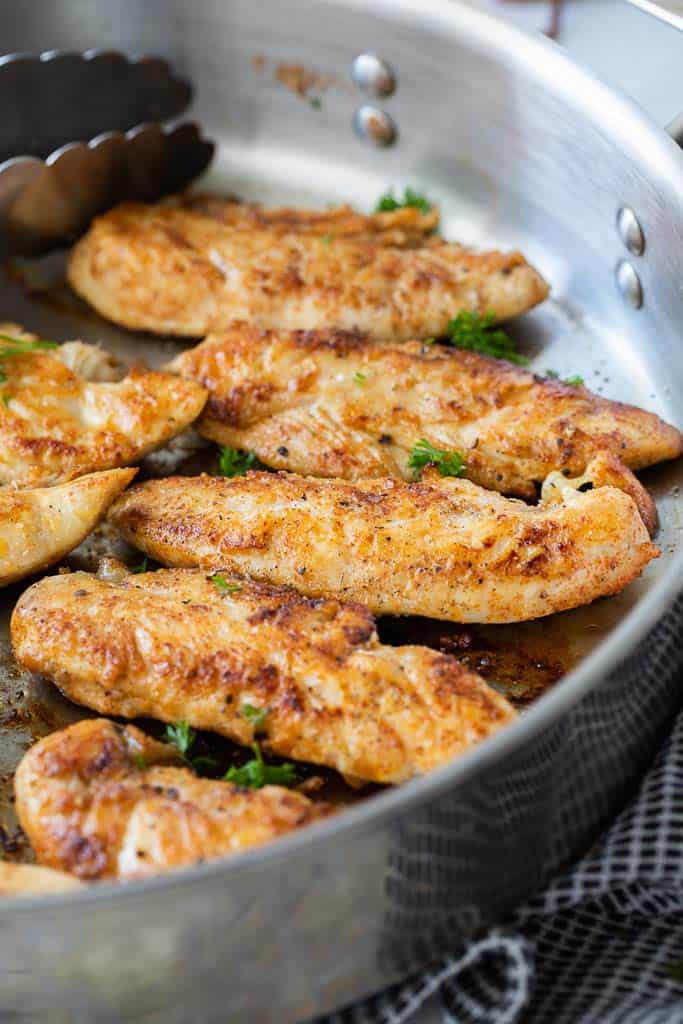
[5,0,683,913]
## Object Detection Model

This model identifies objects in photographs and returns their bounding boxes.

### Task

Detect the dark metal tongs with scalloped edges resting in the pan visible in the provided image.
[0,50,214,258]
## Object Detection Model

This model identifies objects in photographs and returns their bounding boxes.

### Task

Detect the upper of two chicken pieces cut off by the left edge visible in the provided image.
[0,324,206,487]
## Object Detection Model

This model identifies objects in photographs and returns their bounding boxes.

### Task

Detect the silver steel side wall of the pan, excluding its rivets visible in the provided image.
[0,0,683,1024]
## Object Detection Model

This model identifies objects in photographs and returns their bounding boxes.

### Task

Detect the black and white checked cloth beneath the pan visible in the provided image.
[319,712,683,1024]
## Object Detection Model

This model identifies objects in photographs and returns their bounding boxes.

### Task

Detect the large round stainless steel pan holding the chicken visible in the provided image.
[0,0,683,1024]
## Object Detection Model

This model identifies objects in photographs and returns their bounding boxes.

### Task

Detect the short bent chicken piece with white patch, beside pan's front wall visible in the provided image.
[14,719,327,881]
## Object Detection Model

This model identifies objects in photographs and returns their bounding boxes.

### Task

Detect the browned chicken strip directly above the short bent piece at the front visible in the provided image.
[11,569,515,782]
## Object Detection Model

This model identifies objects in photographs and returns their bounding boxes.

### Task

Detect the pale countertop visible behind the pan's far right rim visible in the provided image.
[412,0,683,1024]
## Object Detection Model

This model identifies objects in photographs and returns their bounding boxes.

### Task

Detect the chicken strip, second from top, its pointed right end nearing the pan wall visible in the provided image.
[168,324,683,507]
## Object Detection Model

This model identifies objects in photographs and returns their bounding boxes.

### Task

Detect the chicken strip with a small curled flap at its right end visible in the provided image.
[110,464,658,623]
